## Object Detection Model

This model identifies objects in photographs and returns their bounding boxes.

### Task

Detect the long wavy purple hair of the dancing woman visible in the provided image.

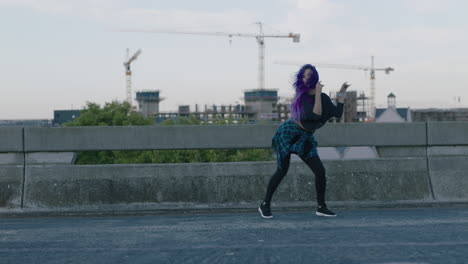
[290,64,319,120]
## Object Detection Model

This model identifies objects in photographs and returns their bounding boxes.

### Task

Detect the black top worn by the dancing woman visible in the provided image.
[301,93,343,131]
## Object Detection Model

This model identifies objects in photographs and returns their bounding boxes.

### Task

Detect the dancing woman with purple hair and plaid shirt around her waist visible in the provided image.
[258,64,350,218]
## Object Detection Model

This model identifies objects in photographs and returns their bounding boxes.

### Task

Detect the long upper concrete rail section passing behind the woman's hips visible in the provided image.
[25,123,426,152]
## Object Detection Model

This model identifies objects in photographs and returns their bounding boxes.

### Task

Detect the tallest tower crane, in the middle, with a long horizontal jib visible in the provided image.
[123,22,301,89]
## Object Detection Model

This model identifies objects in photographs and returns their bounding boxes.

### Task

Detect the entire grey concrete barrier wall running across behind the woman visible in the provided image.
[0,122,468,211]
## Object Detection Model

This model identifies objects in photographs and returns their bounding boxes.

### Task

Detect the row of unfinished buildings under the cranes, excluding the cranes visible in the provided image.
[136,89,369,123]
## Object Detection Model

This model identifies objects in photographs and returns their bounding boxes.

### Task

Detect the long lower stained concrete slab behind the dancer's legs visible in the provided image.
[24,158,431,210]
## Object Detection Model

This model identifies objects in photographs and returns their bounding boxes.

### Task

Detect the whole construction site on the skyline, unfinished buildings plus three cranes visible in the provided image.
[119,22,394,123]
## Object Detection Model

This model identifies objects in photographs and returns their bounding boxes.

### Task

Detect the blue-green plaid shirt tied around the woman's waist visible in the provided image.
[271,119,318,168]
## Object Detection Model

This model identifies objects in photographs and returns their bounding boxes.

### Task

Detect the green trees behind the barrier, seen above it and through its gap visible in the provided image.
[64,101,273,164]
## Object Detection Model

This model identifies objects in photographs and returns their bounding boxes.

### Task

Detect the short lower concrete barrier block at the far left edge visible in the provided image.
[0,165,23,209]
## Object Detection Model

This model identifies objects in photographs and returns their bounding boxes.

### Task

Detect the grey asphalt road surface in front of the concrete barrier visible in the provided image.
[0,208,468,264]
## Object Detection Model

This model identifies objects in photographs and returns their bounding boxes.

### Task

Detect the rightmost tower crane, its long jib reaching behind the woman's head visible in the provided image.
[275,56,395,120]
